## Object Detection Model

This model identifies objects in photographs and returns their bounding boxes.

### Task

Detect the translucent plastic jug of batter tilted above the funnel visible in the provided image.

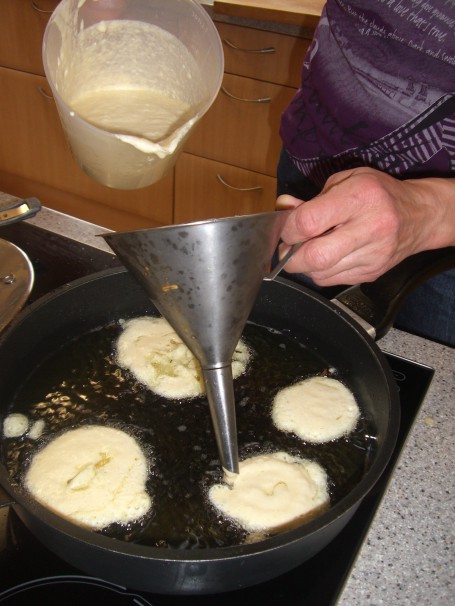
[43,0,224,189]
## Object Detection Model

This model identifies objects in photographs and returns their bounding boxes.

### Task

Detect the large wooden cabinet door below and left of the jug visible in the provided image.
[0,68,173,227]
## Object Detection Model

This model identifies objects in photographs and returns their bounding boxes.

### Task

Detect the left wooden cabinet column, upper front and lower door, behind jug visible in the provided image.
[0,0,174,230]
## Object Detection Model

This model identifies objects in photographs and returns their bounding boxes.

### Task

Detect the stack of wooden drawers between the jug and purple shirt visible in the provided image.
[174,23,310,222]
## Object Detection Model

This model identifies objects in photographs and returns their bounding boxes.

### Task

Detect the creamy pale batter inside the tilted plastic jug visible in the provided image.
[57,20,205,151]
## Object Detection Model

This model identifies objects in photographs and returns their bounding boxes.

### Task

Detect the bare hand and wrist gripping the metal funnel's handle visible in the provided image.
[277,168,455,286]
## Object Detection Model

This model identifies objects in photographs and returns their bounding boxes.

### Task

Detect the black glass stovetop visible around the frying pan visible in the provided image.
[0,223,434,606]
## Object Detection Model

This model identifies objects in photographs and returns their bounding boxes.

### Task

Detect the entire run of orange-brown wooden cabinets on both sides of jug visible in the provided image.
[0,0,318,230]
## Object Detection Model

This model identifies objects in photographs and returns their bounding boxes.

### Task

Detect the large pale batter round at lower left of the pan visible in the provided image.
[25,425,151,529]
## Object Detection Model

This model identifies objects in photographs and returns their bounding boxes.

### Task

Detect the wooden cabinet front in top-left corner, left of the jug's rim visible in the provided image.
[0,0,58,74]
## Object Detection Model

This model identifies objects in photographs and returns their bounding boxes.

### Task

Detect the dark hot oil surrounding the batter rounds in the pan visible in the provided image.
[4,324,375,549]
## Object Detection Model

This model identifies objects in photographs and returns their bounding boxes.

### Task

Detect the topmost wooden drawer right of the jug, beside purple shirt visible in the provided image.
[216,23,310,88]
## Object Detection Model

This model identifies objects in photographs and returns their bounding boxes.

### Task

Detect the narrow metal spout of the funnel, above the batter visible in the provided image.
[202,364,239,473]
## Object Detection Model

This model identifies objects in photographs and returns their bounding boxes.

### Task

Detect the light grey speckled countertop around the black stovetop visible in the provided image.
[0,201,455,606]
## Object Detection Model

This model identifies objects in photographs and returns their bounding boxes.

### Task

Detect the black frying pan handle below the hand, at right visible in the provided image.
[332,246,455,339]
